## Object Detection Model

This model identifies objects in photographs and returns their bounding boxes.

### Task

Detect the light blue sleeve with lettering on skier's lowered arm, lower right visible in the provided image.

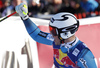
[77,50,97,68]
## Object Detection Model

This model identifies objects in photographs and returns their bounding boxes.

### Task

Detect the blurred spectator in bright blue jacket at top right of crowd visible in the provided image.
[80,0,98,12]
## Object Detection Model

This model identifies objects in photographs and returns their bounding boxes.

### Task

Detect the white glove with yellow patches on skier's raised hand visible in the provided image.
[15,3,29,20]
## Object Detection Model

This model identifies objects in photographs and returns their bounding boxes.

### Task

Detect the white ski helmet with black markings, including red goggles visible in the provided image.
[49,12,79,40]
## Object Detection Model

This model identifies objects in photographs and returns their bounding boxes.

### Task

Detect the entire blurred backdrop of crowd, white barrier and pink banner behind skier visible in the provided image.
[0,0,100,68]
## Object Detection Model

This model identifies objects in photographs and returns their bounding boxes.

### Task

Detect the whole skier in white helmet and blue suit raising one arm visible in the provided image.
[15,3,97,68]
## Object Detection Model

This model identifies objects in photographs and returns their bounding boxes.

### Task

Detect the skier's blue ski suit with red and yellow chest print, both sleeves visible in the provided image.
[23,18,97,68]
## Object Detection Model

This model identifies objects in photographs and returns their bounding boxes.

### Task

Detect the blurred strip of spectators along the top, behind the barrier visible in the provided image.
[0,0,100,19]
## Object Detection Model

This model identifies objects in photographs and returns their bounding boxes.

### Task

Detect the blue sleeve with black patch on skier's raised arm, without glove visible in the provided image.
[23,18,53,45]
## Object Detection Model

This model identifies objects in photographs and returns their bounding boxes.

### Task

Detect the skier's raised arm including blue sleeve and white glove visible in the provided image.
[16,3,53,45]
